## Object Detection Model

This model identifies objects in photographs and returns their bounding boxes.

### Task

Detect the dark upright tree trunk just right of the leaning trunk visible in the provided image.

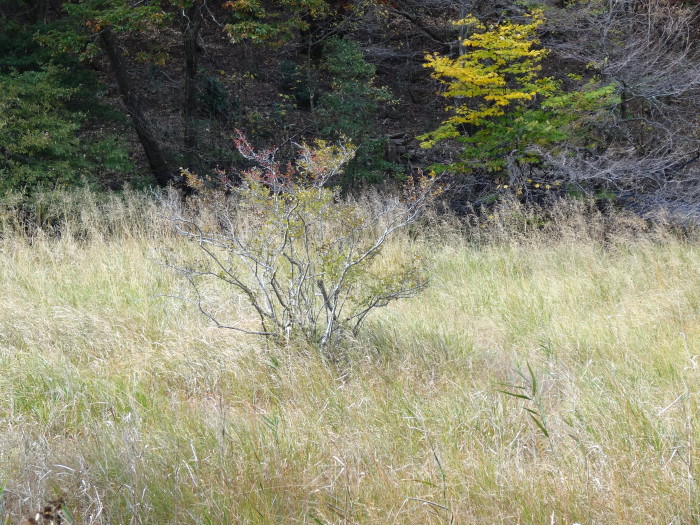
[183,0,202,157]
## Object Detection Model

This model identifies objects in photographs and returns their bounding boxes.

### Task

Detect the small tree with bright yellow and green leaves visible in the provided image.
[419,11,616,173]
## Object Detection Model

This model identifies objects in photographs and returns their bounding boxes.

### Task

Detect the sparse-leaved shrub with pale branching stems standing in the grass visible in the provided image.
[165,134,435,352]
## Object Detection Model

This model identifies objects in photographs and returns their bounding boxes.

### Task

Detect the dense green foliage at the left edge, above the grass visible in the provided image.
[0,66,133,195]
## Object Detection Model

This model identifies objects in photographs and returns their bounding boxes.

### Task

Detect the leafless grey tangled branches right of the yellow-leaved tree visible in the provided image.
[544,0,700,199]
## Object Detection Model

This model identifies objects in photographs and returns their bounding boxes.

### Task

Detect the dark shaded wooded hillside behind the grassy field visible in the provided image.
[0,0,700,214]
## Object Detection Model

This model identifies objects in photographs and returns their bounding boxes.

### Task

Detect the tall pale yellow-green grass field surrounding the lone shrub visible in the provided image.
[0,190,700,525]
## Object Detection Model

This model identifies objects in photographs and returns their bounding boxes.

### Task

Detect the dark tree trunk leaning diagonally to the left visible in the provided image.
[100,29,173,187]
